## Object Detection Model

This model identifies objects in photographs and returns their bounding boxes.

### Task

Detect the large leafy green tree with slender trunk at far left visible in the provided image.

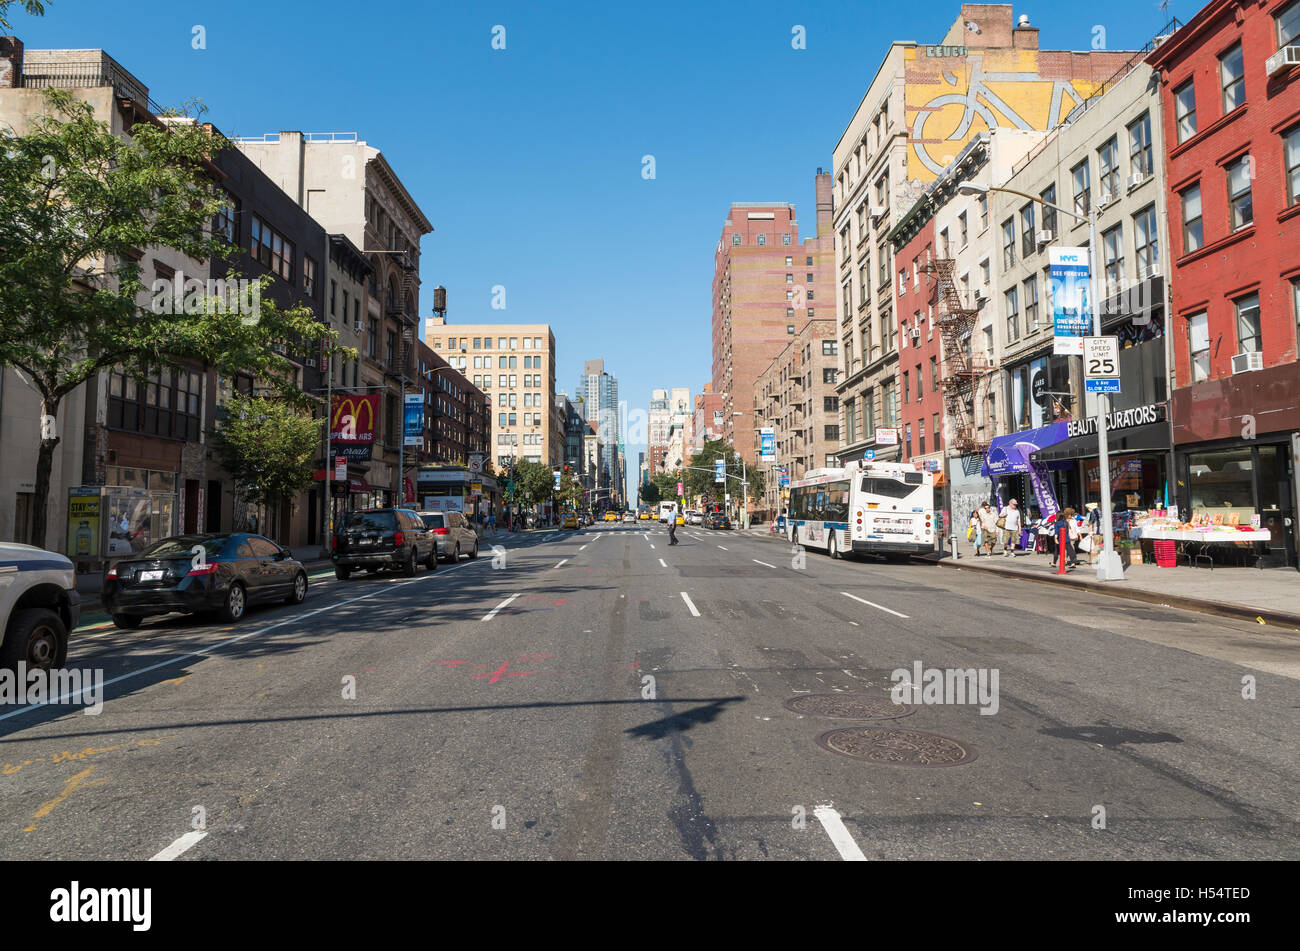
[0,90,345,547]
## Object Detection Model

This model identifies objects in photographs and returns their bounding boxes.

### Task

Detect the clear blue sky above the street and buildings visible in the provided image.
[9,0,1200,501]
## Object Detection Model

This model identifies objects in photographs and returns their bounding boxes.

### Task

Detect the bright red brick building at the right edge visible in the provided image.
[1148,0,1300,564]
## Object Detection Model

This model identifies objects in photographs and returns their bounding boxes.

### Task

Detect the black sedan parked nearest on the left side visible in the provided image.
[104,533,307,628]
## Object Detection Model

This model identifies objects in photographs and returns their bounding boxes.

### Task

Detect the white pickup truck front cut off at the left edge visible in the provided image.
[0,542,81,670]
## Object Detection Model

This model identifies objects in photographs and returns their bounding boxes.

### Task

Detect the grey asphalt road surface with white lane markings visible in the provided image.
[0,522,1300,861]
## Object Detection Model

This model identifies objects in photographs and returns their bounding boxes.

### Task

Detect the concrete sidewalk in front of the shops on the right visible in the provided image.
[927,546,1300,629]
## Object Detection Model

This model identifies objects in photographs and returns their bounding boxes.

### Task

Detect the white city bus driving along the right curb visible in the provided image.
[785,463,937,559]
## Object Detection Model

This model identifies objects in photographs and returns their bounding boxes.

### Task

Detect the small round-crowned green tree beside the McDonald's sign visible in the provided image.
[212,394,325,537]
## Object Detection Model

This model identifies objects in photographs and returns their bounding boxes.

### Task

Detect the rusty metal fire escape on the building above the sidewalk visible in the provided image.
[922,257,995,455]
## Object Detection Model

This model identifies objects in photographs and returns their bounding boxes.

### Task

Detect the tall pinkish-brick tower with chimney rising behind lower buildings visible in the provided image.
[712,169,835,464]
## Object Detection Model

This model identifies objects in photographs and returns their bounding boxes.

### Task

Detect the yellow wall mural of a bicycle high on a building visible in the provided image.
[904,47,1125,182]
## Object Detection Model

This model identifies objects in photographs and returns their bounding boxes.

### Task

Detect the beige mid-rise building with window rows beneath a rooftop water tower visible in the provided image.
[424,317,564,472]
